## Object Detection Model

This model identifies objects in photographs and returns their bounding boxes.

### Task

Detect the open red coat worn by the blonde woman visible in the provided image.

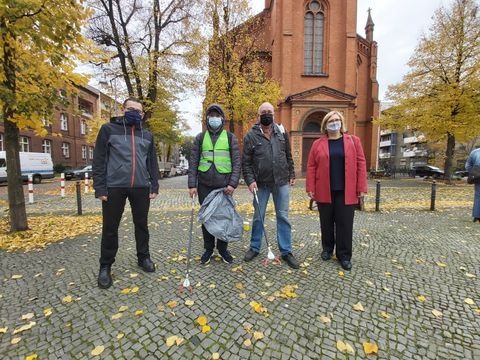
[306,134,367,205]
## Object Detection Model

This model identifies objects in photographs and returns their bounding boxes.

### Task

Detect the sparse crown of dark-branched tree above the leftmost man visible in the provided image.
[88,0,204,126]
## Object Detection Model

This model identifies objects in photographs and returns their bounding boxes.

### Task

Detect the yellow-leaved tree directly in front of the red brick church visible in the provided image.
[205,0,281,132]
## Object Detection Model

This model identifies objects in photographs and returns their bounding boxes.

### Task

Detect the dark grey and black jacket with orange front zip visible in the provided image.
[92,116,159,197]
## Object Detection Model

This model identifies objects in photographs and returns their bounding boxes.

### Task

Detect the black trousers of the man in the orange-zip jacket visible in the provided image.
[100,188,150,265]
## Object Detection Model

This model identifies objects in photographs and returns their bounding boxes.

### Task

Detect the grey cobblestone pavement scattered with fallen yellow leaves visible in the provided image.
[0,178,480,359]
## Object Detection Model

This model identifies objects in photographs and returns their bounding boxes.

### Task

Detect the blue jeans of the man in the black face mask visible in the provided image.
[250,184,292,255]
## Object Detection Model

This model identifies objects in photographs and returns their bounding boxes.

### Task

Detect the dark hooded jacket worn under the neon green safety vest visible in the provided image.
[188,104,242,189]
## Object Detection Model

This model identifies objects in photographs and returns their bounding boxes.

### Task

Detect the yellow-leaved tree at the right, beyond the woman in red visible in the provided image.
[378,0,480,179]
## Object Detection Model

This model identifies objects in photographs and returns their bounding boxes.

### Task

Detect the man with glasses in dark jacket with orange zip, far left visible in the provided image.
[92,98,158,289]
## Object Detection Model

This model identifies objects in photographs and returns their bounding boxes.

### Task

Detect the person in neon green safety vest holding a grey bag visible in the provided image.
[188,104,241,264]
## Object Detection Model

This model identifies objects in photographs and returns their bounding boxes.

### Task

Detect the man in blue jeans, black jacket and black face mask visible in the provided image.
[242,103,299,269]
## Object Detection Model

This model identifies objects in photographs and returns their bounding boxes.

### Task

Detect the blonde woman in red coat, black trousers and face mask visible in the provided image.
[306,111,367,270]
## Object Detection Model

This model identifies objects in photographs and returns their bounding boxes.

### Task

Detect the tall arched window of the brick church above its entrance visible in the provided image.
[304,0,325,75]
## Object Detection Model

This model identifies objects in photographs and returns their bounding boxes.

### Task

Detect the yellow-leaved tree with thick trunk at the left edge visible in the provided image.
[0,0,90,231]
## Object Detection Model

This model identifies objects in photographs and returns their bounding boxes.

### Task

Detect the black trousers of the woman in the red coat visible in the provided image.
[318,191,355,261]
